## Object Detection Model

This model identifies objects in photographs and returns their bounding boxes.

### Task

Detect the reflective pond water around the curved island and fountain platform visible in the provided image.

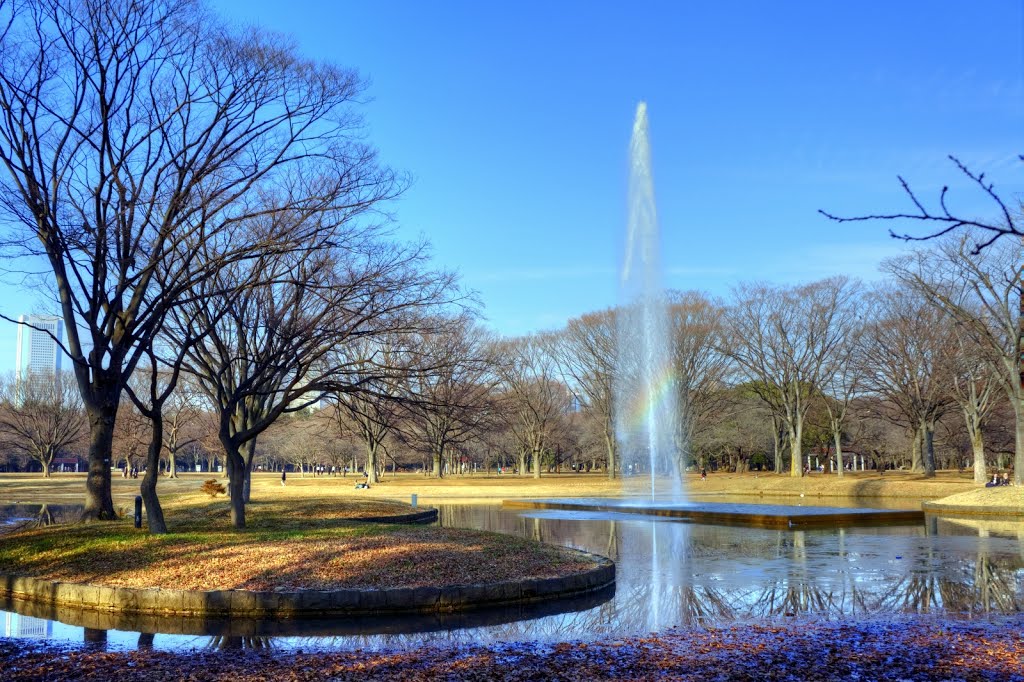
[5,505,1024,649]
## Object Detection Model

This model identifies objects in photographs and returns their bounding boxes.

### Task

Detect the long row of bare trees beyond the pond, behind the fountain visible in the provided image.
[2,233,1017,489]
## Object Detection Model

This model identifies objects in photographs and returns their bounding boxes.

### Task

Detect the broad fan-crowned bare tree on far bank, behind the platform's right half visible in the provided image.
[726,278,857,476]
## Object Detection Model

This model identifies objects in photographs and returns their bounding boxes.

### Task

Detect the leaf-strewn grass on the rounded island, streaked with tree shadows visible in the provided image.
[0,497,595,591]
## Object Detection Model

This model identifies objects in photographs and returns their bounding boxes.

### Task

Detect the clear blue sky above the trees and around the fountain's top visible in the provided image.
[0,0,1024,368]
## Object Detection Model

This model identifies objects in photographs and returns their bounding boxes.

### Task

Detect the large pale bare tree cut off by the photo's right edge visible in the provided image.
[885,232,1024,485]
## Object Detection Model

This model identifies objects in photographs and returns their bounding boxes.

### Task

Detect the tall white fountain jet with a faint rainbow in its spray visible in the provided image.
[614,101,683,502]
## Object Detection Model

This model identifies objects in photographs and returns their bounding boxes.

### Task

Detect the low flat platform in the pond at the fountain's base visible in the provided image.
[502,498,925,528]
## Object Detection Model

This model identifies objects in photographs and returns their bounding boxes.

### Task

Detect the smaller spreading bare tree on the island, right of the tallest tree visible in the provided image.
[173,236,460,528]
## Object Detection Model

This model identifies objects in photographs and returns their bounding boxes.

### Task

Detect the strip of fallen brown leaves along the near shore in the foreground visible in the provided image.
[0,616,1024,682]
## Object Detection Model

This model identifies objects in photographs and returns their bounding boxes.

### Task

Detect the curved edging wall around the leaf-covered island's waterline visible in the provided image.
[0,550,615,617]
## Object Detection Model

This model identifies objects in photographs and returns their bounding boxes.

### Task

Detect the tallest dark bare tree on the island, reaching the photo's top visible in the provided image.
[0,0,396,518]
